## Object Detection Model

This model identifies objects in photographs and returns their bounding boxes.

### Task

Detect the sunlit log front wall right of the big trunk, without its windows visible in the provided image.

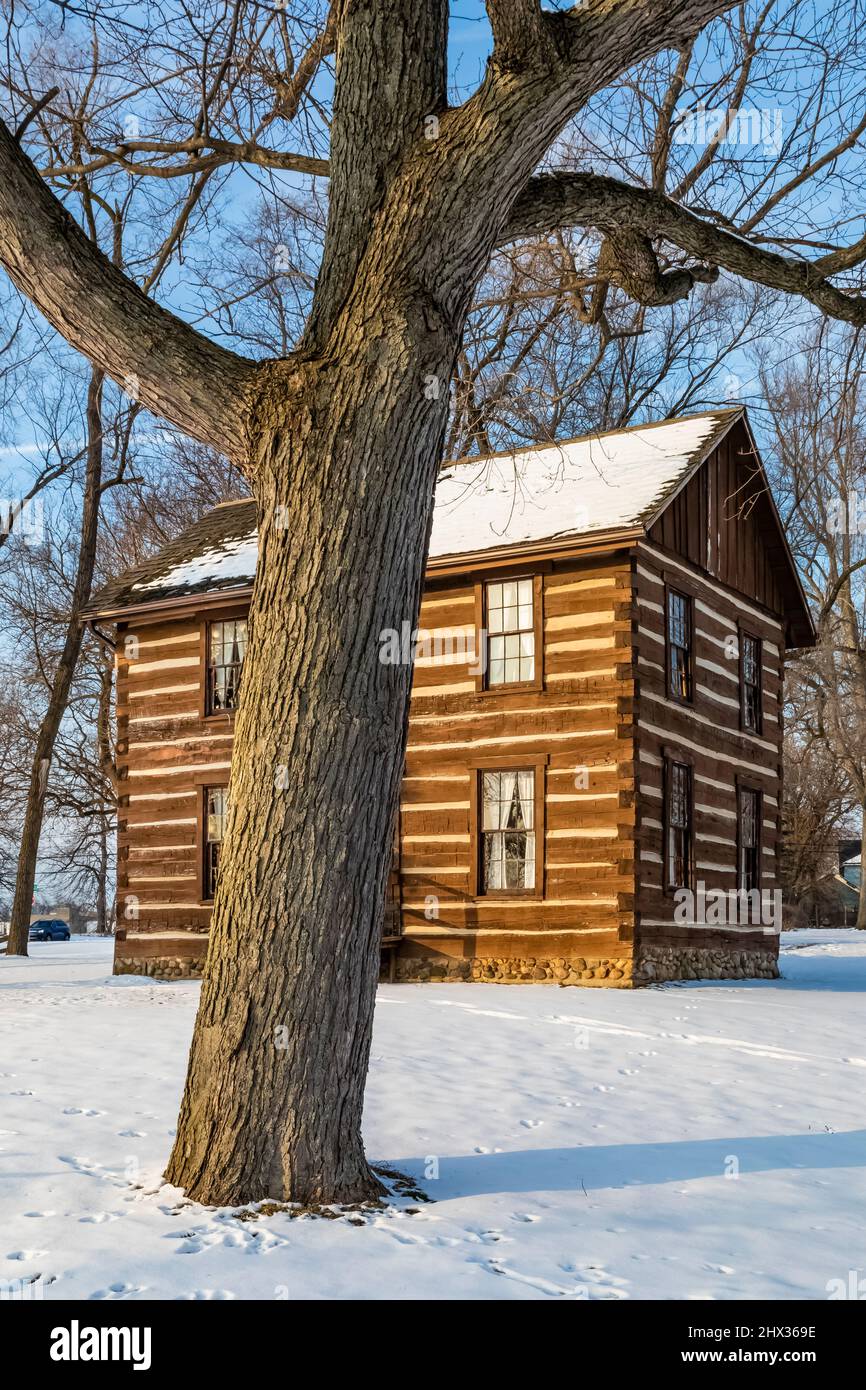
[398,553,635,981]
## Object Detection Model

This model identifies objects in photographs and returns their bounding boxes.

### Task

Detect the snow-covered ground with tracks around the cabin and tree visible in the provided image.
[0,931,866,1300]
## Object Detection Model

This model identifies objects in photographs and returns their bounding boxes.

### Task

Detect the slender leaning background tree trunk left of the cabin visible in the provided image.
[7,370,103,955]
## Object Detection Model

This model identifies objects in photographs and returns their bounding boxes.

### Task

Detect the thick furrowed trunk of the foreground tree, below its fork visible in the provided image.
[167,324,456,1204]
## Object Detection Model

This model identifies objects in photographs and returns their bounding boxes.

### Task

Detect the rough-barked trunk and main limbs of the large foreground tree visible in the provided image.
[0,0,855,1202]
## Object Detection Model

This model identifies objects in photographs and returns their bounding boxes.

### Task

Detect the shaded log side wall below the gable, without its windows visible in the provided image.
[635,530,784,977]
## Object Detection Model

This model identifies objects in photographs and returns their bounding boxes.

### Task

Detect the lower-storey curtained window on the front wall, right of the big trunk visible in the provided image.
[481,769,535,892]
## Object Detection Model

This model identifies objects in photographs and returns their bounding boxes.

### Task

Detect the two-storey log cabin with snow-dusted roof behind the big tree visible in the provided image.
[86,407,815,988]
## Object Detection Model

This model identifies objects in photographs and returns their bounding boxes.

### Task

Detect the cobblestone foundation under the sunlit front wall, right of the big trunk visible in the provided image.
[382,955,632,990]
